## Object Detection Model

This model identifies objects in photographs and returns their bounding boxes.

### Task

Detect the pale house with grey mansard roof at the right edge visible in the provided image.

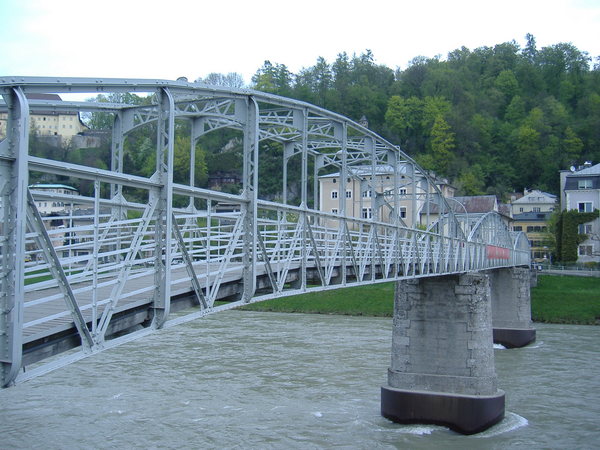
[560,162,600,263]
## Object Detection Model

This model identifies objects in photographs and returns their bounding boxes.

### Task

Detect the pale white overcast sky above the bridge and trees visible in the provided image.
[0,0,600,83]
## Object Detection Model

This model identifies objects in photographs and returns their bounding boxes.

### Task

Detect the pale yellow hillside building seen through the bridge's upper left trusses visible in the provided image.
[0,94,88,143]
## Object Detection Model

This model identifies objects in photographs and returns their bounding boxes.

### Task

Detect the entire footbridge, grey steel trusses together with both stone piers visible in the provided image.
[0,77,535,433]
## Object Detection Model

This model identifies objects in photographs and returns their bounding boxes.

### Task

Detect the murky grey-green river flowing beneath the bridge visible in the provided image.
[0,311,600,449]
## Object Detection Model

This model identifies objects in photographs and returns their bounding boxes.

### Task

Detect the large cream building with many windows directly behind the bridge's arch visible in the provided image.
[319,164,455,227]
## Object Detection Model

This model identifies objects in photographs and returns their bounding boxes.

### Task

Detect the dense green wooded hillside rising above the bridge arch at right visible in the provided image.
[244,35,600,196]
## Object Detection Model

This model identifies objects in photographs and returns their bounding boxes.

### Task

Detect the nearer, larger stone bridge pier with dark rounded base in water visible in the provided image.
[381,274,504,434]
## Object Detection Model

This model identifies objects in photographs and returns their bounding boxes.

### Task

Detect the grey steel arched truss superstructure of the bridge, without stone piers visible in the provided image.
[0,77,529,386]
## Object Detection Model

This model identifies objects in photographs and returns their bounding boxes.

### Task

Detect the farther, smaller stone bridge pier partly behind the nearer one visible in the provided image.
[489,267,535,348]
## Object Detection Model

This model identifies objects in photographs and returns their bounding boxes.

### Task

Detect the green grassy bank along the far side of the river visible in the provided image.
[242,275,600,325]
